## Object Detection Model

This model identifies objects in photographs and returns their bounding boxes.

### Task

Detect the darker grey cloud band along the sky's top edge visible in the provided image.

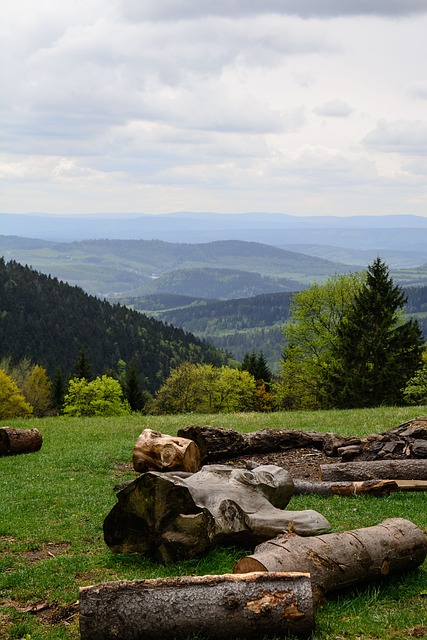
[121,0,427,21]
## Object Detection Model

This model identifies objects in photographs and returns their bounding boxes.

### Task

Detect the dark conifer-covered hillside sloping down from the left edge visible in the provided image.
[0,259,225,392]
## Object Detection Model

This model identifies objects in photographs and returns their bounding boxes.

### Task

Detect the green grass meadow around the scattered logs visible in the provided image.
[0,406,427,640]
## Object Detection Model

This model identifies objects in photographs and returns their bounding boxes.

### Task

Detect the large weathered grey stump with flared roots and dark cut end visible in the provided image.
[104,465,330,563]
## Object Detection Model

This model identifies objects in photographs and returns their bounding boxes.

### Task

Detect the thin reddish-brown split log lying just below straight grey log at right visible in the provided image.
[294,478,402,496]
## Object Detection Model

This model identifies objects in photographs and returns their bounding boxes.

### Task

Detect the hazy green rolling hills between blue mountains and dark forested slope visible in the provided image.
[0,236,350,298]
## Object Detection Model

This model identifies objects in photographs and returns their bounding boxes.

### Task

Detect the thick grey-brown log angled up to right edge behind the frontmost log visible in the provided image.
[234,518,427,602]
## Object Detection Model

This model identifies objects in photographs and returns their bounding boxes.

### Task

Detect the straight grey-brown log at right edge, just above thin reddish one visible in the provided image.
[320,459,427,482]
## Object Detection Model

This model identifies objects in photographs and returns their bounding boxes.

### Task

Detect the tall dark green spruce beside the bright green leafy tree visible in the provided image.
[326,258,423,408]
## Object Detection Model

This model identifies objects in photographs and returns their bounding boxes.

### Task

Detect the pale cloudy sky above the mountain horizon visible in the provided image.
[0,0,427,216]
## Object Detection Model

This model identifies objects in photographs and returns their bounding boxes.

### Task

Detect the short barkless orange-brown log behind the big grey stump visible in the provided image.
[133,429,200,473]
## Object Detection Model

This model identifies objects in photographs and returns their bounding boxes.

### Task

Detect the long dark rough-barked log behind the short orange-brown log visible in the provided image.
[178,426,361,462]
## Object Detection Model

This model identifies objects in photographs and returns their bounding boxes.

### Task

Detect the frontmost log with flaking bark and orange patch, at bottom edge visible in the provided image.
[79,572,314,640]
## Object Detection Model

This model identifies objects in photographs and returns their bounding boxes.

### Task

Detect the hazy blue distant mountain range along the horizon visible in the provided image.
[0,212,427,268]
